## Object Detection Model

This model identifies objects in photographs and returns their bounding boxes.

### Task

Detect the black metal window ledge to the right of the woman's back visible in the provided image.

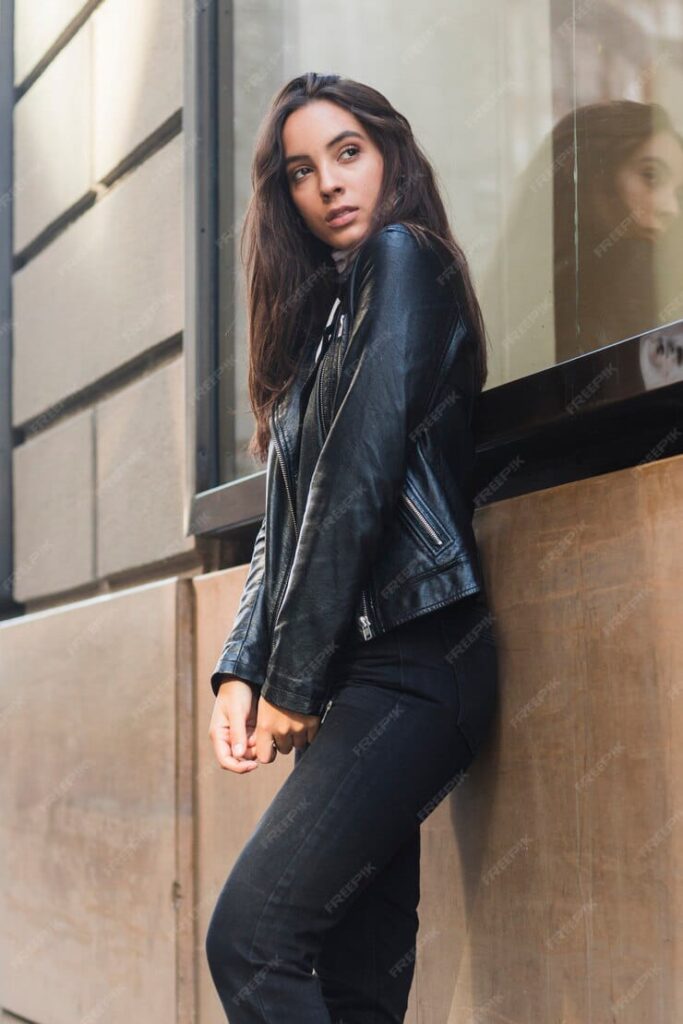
[473,321,683,507]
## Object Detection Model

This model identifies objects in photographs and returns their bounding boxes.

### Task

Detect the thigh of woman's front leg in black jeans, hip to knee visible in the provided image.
[215,684,471,967]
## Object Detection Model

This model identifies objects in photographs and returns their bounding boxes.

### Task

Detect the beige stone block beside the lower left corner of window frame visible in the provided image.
[96,358,195,577]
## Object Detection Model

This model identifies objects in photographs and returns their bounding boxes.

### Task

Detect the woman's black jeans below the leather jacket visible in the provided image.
[206,595,498,1024]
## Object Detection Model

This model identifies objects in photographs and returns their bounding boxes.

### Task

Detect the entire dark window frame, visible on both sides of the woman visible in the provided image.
[183,0,683,538]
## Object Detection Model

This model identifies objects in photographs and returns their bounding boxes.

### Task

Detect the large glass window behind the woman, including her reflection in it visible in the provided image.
[219,0,683,482]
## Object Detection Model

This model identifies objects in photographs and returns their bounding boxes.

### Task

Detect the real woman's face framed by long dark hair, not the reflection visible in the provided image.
[283,99,384,249]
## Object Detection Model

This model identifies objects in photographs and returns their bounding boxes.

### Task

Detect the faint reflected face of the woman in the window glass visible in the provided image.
[615,131,683,241]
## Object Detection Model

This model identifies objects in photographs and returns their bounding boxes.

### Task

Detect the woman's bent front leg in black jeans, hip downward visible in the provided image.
[206,683,471,1024]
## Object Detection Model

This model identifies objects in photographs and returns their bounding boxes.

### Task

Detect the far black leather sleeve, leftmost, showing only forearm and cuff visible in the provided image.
[211,516,269,695]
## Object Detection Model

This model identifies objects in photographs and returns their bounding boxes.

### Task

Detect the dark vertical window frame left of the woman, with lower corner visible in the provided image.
[183,0,265,537]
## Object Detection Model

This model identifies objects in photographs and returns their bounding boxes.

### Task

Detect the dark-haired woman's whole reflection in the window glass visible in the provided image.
[553,99,683,361]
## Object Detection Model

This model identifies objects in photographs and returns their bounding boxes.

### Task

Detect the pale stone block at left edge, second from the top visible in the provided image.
[13,22,92,251]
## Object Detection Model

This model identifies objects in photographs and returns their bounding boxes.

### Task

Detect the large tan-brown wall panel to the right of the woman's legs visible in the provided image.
[413,456,683,1024]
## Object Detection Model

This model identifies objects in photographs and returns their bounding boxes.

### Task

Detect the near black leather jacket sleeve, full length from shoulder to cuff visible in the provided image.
[261,224,457,715]
